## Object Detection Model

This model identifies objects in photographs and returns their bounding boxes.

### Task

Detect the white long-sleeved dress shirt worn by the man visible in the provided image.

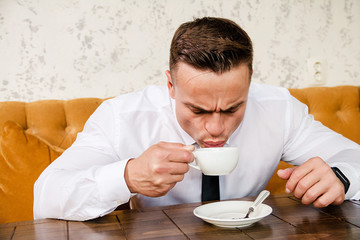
[34,83,360,220]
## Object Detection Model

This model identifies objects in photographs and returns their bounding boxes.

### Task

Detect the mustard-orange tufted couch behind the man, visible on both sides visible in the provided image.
[0,86,360,223]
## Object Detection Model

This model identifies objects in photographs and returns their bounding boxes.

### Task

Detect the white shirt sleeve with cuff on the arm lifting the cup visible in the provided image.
[34,102,131,221]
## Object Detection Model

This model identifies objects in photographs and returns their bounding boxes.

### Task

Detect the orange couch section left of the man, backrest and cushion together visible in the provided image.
[0,98,104,223]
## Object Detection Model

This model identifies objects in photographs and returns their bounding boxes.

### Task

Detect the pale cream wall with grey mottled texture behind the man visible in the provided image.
[0,0,360,101]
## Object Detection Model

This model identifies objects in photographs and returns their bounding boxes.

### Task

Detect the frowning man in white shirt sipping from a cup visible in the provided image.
[34,18,360,220]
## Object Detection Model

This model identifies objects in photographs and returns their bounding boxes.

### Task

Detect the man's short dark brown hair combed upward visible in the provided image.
[170,17,253,73]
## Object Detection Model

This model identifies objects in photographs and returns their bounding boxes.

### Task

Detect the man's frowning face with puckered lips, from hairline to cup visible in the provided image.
[166,63,250,147]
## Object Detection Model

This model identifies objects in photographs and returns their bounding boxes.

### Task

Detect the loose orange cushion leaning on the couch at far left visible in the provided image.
[0,121,64,224]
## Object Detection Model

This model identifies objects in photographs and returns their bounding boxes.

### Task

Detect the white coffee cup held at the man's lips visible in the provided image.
[189,147,239,176]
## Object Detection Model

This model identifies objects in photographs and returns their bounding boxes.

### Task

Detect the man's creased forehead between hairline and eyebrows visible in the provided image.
[172,63,250,108]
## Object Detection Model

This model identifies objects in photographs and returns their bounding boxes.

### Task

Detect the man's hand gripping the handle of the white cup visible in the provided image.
[124,142,195,197]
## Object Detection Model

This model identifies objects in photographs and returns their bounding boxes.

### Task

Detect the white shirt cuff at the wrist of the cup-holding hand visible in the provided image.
[96,159,133,205]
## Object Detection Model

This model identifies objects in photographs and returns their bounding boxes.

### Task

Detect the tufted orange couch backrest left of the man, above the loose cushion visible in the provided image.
[0,98,104,149]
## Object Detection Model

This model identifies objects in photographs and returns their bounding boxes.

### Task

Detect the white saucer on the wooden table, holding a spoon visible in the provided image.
[193,201,272,228]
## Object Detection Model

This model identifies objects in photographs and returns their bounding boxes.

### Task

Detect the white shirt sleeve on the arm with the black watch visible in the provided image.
[282,94,360,200]
